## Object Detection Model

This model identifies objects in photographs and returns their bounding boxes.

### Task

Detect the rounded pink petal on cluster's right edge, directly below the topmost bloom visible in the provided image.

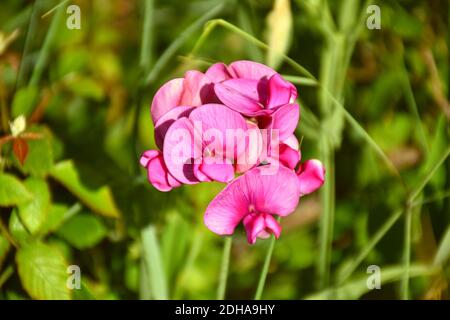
[270,103,300,141]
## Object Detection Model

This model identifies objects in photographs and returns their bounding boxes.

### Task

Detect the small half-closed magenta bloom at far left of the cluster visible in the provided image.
[140,150,181,192]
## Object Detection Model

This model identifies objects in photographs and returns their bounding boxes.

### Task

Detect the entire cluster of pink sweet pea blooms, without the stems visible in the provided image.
[140,61,325,244]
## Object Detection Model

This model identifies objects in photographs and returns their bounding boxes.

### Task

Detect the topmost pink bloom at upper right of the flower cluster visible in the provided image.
[209,61,299,140]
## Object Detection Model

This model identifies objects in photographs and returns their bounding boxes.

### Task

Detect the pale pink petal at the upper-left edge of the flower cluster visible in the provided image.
[150,78,184,123]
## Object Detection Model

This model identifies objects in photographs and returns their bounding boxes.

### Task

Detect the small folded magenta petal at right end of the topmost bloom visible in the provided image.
[266,74,297,109]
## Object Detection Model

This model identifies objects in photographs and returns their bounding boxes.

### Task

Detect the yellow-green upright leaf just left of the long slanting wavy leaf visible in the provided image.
[18,178,50,234]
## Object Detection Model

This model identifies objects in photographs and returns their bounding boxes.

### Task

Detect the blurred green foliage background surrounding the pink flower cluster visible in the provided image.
[0,0,450,299]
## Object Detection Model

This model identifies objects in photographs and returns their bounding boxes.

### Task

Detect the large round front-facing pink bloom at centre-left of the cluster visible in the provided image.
[163,104,259,184]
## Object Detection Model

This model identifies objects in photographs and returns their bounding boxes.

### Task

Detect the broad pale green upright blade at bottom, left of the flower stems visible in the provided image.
[142,225,169,300]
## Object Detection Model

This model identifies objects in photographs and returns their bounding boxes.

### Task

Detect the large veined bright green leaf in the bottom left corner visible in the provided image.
[16,242,71,300]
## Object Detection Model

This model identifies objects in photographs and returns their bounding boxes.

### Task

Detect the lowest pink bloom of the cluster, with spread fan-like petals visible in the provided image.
[204,166,300,244]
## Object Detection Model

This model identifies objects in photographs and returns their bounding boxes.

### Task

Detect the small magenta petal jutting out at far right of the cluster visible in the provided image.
[297,159,325,195]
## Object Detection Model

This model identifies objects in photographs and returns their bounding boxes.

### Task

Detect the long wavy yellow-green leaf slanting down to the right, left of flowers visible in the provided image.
[50,160,120,218]
